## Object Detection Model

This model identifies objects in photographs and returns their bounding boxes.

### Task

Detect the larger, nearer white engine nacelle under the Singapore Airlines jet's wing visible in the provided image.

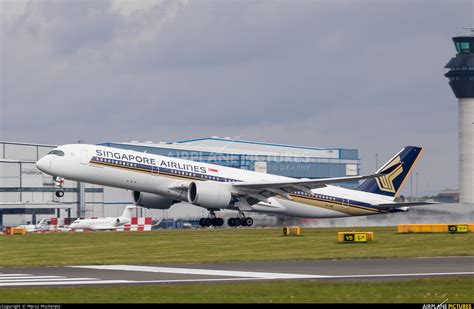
[188,181,232,209]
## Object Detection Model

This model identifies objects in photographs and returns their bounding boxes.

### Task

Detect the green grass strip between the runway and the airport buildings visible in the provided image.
[0,227,474,267]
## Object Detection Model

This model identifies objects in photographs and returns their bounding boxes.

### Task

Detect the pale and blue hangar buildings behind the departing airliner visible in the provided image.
[0,136,360,226]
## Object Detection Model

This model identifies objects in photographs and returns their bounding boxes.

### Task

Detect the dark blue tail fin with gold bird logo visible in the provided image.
[357,146,423,198]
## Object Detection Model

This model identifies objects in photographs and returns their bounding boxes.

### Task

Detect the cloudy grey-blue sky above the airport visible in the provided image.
[0,0,474,196]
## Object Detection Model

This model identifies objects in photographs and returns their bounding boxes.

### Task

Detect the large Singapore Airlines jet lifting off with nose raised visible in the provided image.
[36,144,423,226]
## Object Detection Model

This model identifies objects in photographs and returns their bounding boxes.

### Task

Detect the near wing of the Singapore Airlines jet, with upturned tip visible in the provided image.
[232,163,401,205]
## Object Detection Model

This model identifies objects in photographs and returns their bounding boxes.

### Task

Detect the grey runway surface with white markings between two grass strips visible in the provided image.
[0,256,474,287]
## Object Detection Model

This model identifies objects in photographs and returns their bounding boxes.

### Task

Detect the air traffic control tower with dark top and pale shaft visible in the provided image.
[445,28,474,204]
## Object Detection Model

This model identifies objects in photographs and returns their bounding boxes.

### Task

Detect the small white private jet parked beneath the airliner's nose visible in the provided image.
[69,206,136,231]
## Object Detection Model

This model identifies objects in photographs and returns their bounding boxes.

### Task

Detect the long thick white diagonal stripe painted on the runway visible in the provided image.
[69,265,328,279]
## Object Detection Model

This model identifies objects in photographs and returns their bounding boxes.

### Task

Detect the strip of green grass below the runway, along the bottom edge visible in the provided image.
[0,276,474,304]
